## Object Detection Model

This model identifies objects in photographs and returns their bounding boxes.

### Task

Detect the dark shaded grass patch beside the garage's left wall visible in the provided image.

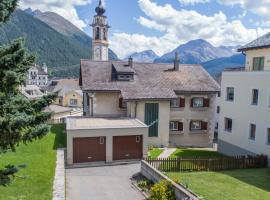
[51,124,67,150]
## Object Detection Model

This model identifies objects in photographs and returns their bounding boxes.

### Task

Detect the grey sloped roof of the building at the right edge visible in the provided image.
[238,33,270,51]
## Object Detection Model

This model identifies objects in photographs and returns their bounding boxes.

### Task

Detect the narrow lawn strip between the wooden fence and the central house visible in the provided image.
[170,148,224,158]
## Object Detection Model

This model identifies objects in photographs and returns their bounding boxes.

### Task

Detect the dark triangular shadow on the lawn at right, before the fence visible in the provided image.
[218,168,270,191]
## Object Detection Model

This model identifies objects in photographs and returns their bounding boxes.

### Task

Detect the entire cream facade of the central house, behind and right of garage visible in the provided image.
[84,92,216,147]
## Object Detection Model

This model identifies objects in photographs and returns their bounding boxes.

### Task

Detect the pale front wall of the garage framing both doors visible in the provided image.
[67,127,148,165]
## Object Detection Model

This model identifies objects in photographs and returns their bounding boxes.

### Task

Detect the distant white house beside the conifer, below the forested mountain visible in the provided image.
[26,63,48,87]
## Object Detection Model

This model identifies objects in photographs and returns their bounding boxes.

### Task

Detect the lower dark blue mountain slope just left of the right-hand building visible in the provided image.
[201,54,245,77]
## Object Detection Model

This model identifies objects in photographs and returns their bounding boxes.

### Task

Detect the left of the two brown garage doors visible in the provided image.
[73,137,106,163]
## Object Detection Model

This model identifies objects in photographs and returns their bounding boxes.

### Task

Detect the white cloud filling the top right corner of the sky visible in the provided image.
[218,0,270,20]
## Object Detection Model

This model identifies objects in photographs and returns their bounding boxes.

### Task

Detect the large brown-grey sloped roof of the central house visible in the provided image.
[80,60,220,100]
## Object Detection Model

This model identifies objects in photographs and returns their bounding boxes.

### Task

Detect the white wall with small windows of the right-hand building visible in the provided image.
[218,71,270,159]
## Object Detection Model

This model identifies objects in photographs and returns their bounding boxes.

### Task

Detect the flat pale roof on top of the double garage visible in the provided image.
[67,117,148,130]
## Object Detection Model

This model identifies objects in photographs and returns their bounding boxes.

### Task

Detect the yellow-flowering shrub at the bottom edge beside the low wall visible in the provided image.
[151,180,175,200]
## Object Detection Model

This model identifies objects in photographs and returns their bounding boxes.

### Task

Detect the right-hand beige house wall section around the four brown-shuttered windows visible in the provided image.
[168,94,216,147]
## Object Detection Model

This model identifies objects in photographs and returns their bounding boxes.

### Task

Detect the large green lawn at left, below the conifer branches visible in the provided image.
[0,125,66,200]
